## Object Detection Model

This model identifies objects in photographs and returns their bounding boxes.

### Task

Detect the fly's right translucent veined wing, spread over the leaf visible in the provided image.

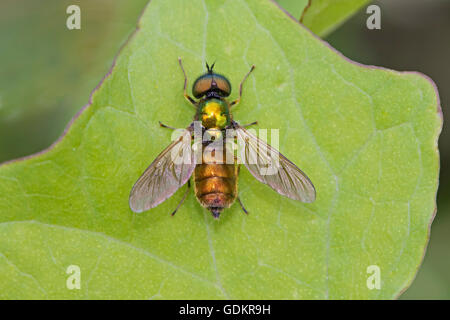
[234,123,316,202]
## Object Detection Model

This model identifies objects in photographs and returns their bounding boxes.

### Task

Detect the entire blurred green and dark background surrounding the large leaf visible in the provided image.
[0,0,450,299]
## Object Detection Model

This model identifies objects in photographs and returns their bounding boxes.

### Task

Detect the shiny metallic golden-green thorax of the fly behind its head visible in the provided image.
[197,98,231,130]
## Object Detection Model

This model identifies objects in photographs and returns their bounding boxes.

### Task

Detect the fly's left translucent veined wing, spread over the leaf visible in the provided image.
[129,130,195,212]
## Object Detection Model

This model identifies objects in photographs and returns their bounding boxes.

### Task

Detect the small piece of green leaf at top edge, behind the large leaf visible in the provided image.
[300,0,370,38]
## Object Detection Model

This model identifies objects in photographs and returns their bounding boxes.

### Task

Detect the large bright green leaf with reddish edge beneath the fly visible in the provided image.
[0,0,442,299]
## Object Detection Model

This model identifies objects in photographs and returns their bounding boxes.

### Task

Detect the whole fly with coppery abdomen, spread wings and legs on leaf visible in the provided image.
[129,59,316,218]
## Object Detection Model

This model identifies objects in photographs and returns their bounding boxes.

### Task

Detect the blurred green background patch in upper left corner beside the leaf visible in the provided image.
[0,0,146,162]
